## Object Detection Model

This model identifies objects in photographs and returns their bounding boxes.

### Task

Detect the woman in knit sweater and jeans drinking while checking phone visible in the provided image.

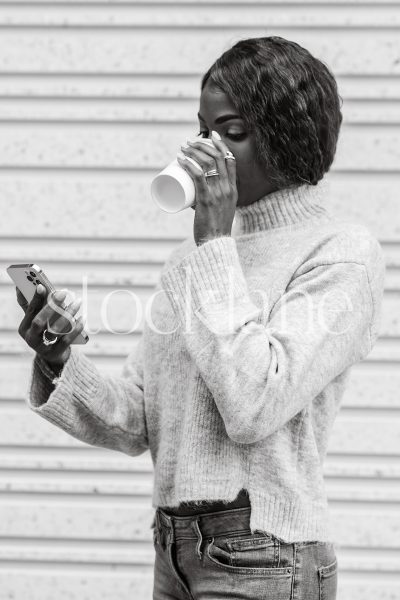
[19,36,385,600]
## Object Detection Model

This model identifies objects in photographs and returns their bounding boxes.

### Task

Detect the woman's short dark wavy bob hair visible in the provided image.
[201,36,343,187]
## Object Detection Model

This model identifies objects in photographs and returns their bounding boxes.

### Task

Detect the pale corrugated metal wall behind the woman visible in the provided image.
[0,0,400,600]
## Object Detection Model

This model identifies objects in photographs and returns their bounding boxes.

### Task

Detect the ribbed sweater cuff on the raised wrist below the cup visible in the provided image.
[161,236,259,333]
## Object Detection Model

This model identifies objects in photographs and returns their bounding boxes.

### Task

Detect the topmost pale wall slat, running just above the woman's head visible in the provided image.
[0,1,400,31]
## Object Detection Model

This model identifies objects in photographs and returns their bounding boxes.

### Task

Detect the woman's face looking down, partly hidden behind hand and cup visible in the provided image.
[198,80,277,206]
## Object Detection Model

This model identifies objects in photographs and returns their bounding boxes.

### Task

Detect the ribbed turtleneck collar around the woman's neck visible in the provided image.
[234,180,329,235]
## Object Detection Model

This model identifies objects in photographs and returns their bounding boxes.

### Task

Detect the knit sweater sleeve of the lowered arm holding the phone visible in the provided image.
[27,336,148,456]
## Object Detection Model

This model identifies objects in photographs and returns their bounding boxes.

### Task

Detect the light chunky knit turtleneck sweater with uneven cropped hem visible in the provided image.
[27,182,385,543]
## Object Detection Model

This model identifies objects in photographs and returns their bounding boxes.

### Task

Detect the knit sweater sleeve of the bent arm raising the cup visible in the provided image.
[159,236,382,444]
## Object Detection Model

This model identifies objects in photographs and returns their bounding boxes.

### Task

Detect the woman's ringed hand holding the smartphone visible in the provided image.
[15,284,84,367]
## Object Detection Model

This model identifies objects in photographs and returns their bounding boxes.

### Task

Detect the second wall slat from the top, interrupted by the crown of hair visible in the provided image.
[0,31,400,76]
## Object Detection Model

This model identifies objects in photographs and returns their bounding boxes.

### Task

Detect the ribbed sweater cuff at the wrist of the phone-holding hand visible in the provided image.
[27,349,100,431]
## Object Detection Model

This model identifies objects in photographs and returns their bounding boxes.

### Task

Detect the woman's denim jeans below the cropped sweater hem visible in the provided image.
[151,507,338,600]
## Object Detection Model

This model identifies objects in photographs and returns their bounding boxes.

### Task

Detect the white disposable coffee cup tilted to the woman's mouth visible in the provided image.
[150,138,214,213]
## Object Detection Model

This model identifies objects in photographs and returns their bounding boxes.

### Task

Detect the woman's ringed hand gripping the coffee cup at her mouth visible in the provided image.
[177,131,238,246]
